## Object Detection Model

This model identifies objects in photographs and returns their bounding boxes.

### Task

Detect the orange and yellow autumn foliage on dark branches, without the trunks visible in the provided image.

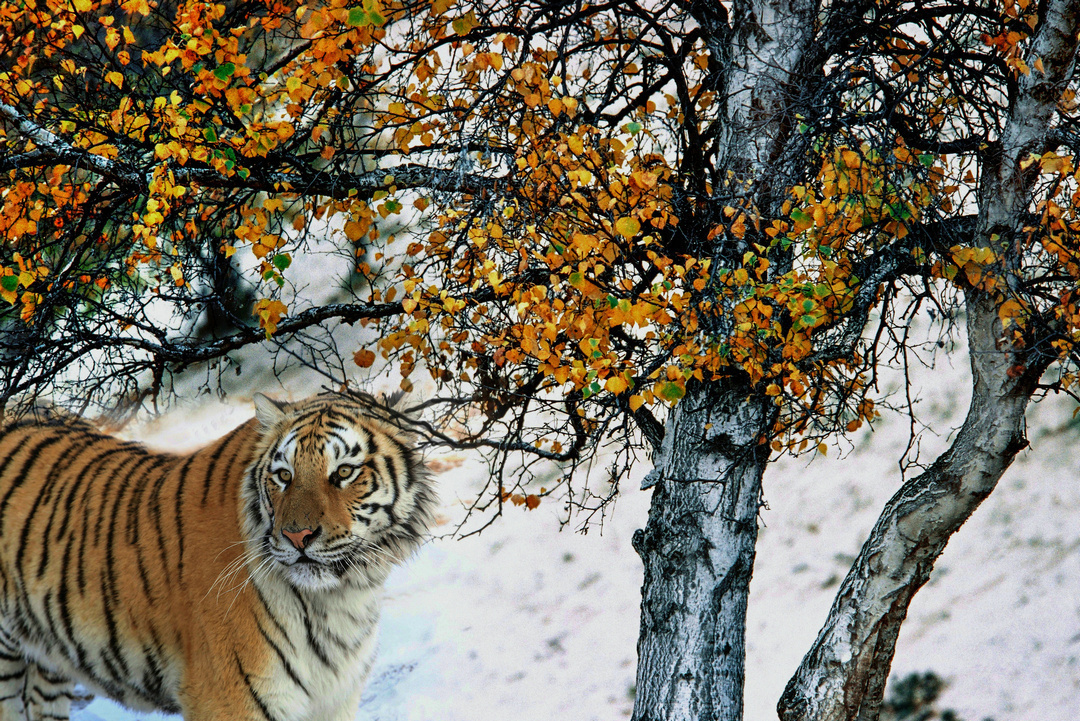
[0,0,1080,479]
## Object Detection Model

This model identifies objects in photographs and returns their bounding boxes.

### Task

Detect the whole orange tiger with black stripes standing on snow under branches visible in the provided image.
[0,394,436,721]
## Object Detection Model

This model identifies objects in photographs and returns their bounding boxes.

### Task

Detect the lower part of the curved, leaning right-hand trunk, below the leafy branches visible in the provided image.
[777,294,1041,721]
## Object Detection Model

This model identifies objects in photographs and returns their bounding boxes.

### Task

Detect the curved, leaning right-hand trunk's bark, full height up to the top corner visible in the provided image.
[778,0,1080,721]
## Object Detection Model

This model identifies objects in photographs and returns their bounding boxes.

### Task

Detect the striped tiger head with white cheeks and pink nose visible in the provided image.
[244,394,435,590]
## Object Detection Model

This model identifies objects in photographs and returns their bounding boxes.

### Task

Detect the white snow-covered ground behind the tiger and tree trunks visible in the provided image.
[75,351,1080,721]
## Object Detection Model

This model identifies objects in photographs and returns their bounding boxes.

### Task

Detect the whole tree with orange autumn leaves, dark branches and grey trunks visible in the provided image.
[0,0,1080,721]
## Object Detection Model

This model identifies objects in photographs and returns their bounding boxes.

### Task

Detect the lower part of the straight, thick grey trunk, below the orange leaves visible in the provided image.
[633,382,775,721]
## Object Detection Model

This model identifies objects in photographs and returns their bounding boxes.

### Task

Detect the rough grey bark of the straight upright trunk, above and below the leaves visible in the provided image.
[633,0,821,721]
